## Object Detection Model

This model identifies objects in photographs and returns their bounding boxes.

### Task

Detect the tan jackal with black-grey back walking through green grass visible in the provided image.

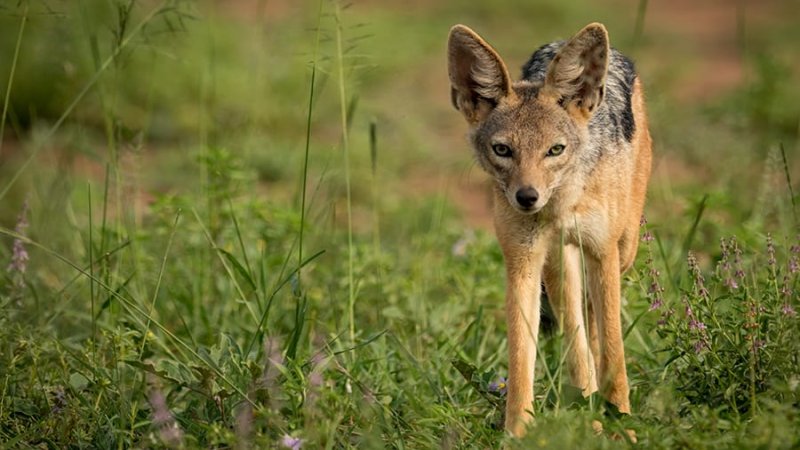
[447,23,652,436]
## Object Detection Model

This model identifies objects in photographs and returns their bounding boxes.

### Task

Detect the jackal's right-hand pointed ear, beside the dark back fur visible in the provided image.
[542,23,610,119]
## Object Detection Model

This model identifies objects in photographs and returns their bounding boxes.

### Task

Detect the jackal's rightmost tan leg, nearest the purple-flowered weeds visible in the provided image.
[589,246,631,414]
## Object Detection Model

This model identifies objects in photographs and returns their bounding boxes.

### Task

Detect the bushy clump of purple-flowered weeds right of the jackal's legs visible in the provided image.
[658,235,800,417]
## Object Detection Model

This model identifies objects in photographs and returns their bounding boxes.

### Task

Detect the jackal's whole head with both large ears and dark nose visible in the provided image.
[448,23,609,214]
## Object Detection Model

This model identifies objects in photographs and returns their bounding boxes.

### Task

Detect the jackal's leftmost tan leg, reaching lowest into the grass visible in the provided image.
[501,242,545,436]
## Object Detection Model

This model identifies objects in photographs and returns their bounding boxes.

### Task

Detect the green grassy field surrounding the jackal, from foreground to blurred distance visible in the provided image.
[0,0,800,448]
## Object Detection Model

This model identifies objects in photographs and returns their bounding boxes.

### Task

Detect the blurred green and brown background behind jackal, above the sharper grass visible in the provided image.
[0,0,800,232]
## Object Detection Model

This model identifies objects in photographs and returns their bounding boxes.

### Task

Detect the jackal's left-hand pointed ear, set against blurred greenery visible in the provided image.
[447,25,512,125]
